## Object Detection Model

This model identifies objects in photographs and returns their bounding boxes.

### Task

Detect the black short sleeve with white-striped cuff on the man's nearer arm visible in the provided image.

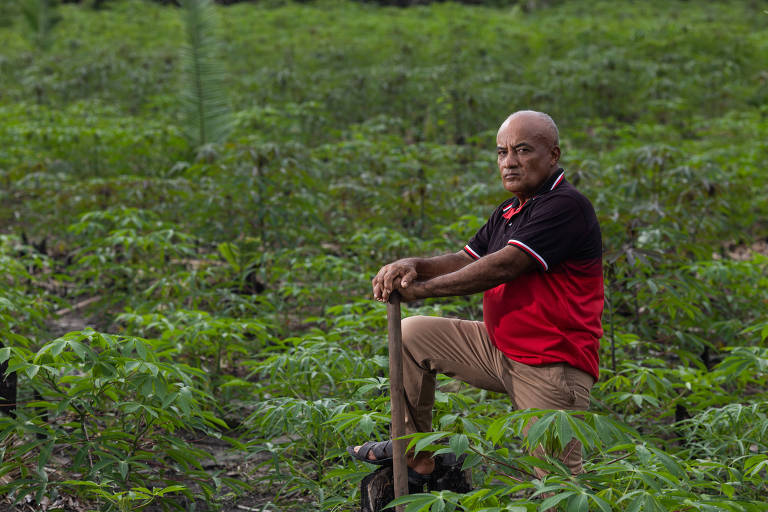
[507,194,601,270]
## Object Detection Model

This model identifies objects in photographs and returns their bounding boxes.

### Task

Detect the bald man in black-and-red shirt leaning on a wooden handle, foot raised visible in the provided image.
[349,111,603,478]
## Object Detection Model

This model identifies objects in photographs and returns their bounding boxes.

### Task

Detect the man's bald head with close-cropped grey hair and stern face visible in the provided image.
[496,115,560,203]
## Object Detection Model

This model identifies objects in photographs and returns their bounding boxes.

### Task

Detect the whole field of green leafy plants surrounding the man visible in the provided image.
[0,0,768,512]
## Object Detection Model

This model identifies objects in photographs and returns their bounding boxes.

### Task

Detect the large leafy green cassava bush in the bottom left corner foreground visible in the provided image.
[0,330,231,510]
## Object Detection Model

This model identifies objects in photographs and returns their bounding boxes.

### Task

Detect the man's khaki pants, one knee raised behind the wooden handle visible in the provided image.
[402,316,594,477]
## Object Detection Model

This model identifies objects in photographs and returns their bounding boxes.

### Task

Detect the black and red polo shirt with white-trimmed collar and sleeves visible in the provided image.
[464,169,604,379]
